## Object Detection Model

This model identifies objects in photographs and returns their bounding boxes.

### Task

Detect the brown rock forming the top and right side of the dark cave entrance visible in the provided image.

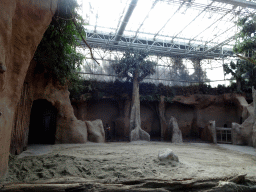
[25,61,87,143]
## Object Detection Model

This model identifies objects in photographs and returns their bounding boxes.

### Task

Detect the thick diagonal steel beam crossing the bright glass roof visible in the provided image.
[114,0,138,44]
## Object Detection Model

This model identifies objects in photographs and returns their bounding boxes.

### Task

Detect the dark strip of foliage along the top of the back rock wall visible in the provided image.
[70,80,240,102]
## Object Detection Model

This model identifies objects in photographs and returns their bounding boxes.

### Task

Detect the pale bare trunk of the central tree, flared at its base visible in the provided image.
[130,72,150,141]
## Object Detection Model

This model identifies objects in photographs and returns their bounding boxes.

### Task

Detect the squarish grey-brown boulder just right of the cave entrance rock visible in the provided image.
[85,119,105,143]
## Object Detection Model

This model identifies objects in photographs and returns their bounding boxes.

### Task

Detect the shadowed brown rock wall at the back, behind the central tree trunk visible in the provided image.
[72,94,244,141]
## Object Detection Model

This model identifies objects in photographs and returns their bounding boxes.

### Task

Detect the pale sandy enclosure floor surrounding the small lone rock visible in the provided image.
[2,142,256,183]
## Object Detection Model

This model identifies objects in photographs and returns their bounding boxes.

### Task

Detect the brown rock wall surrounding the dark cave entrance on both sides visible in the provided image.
[10,60,87,154]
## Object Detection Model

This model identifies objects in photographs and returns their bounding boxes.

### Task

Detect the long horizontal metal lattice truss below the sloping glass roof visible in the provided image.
[81,33,233,59]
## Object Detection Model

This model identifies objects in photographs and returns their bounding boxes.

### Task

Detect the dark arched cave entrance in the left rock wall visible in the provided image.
[28,99,57,144]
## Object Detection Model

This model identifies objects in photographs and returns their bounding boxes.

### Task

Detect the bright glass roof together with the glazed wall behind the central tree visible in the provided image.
[78,0,256,86]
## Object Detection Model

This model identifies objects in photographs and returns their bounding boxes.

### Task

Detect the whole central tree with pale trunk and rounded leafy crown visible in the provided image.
[113,49,156,141]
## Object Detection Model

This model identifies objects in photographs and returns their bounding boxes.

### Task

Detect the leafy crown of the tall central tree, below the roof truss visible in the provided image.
[113,49,156,82]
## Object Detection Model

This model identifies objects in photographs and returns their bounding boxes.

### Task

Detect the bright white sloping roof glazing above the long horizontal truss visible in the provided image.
[78,0,255,58]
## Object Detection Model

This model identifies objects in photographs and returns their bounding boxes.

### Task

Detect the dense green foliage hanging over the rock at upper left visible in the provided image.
[34,0,84,86]
